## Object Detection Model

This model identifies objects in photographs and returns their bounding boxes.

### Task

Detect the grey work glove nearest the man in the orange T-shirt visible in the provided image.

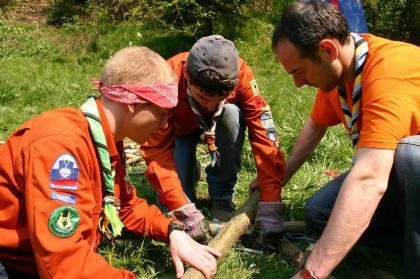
[254,202,286,240]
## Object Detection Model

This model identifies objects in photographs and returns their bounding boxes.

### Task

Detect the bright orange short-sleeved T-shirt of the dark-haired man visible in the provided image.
[311,34,420,149]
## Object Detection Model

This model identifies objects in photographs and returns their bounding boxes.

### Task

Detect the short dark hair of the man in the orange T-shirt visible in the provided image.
[271,0,350,61]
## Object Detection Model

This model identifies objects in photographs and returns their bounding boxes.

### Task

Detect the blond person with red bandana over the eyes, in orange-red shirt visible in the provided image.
[0,47,220,278]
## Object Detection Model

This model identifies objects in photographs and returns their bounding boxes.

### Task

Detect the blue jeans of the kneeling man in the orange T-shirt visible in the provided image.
[305,136,420,279]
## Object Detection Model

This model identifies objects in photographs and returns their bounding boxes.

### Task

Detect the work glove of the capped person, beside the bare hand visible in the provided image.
[168,203,210,243]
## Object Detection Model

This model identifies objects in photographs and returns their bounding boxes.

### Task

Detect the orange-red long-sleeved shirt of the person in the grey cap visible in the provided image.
[141,52,285,210]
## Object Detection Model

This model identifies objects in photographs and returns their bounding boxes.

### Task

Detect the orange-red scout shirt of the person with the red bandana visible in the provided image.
[0,100,170,278]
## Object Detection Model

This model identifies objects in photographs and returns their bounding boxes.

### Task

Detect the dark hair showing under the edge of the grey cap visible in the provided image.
[188,70,235,97]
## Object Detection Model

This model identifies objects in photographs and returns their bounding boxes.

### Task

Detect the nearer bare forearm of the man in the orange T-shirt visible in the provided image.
[306,148,393,278]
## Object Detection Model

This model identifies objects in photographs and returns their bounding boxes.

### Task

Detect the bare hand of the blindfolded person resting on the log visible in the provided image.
[169,231,221,279]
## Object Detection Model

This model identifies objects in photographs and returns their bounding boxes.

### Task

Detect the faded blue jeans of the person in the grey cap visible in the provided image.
[174,104,246,205]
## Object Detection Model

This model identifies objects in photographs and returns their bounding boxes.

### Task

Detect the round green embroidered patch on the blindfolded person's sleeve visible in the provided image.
[48,205,80,238]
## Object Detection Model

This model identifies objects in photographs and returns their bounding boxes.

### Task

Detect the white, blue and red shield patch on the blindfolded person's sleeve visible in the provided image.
[50,153,79,190]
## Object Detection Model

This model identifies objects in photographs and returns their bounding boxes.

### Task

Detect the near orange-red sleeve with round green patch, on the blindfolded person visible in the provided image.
[20,131,135,278]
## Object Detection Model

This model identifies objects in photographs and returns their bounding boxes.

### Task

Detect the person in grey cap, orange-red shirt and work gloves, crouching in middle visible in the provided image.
[141,35,285,239]
